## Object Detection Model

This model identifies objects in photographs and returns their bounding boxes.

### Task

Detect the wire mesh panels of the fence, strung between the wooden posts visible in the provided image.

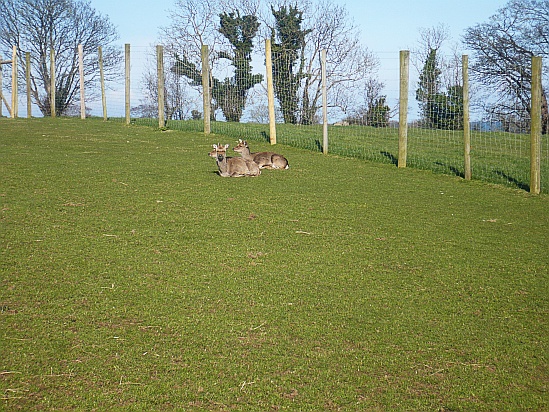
[0,45,549,193]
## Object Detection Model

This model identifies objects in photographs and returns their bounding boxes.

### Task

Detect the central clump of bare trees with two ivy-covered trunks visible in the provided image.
[148,0,381,124]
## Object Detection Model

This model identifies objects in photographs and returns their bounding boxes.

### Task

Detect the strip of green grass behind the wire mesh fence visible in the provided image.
[134,119,549,194]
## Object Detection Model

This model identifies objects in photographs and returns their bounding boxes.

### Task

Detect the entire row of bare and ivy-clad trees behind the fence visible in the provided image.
[0,0,549,134]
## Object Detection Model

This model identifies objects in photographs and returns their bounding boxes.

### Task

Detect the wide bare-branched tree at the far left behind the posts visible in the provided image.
[0,0,121,116]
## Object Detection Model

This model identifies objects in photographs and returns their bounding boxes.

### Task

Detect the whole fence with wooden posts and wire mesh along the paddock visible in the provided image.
[0,40,549,193]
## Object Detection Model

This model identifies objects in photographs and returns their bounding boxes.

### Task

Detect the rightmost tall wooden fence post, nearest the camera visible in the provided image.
[530,56,541,195]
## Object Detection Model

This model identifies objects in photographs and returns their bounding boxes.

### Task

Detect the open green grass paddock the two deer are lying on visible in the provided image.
[0,119,549,412]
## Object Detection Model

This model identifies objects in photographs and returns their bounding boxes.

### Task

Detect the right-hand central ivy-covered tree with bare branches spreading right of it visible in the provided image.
[271,0,379,124]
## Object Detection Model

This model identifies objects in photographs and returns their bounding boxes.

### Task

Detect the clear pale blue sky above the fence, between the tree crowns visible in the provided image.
[91,0,508,53]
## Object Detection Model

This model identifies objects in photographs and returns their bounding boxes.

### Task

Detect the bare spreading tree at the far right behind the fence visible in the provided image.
[464,0,549,134]
